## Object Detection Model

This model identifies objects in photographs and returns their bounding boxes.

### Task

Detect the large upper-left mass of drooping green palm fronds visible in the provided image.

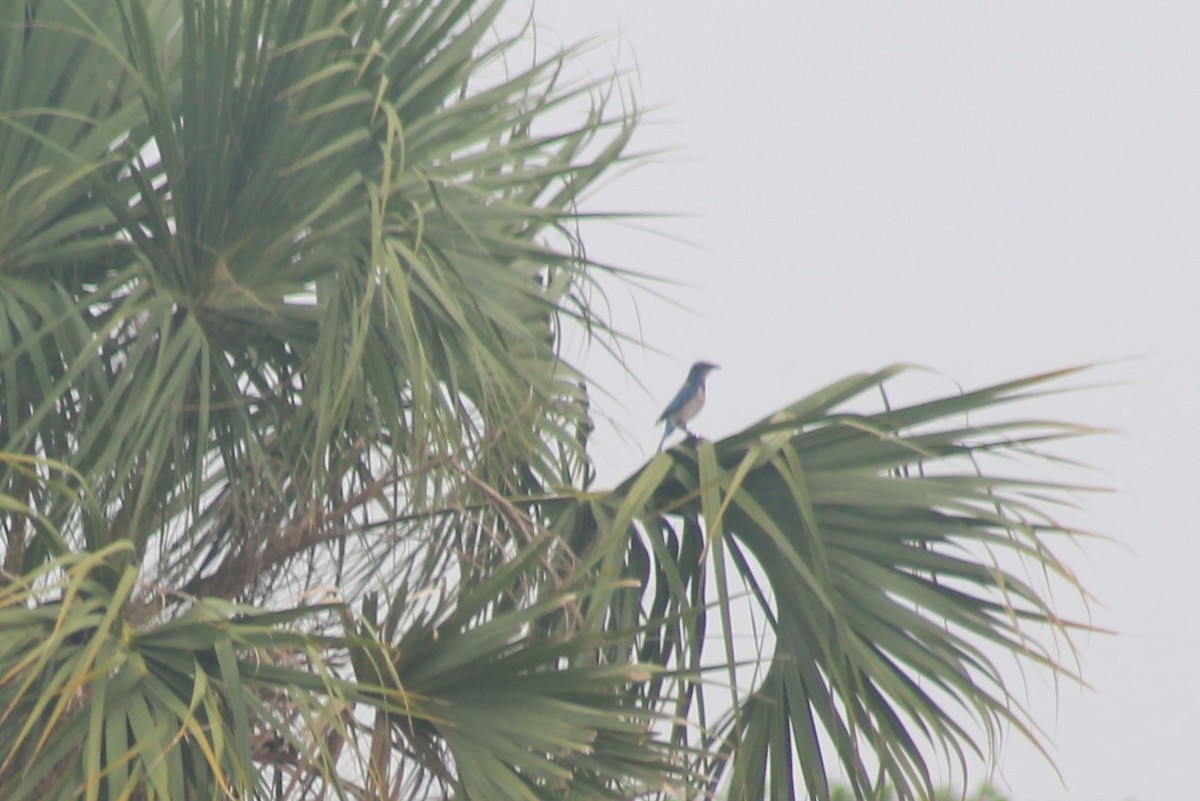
[0,0,632,597]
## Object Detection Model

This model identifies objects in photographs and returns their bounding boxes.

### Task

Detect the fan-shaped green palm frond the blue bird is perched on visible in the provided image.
[550,368,1090,799]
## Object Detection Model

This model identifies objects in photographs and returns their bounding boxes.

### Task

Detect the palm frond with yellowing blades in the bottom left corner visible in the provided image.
[0,543,348,801]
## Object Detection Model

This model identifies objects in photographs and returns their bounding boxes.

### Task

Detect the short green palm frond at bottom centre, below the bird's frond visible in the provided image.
[350,535,696,799]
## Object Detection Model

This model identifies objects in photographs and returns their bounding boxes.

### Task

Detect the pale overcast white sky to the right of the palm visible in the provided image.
[514,0,1200,801]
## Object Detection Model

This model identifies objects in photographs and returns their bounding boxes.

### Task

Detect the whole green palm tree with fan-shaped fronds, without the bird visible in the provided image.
[0,0,1099,801]
